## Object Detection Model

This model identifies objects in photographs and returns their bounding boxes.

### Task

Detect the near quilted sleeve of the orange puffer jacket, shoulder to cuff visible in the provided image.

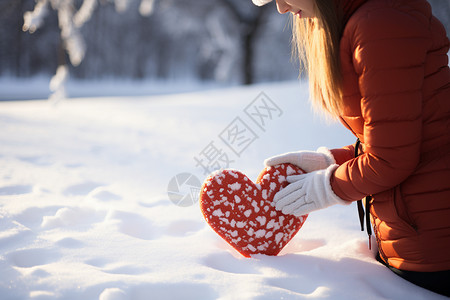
[331,8,429,200]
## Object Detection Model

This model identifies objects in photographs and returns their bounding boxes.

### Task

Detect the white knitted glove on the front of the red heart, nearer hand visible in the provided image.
[273,164,351,216]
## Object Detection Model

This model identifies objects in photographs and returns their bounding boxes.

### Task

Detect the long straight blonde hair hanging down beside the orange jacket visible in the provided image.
[292,0,343,118]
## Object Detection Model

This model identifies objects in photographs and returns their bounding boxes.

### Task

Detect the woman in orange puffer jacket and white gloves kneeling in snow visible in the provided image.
[253,0,450,296]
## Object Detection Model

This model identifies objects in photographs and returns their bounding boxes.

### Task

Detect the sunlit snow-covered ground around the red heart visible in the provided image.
[0,83,444,300]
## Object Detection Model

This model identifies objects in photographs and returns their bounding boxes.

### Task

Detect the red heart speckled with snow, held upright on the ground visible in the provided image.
[200,164,308,257]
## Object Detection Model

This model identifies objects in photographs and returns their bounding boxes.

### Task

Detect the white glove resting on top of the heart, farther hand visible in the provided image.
[264,147,336,173]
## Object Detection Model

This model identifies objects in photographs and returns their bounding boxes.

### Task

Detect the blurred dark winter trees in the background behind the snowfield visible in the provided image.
[0,0,450,85]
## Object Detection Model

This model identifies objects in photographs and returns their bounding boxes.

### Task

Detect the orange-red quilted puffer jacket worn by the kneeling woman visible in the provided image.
[331,0,450,272]
